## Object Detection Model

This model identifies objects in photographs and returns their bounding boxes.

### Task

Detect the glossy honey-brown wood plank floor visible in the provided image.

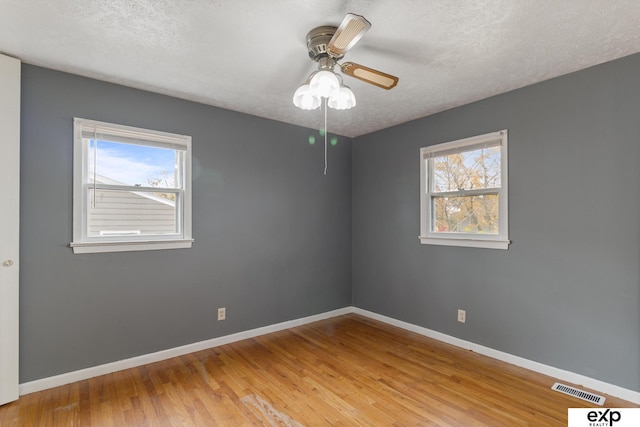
[0,314,638,427]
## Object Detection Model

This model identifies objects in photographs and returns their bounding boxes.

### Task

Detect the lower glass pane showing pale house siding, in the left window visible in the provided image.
[88,189,179,237]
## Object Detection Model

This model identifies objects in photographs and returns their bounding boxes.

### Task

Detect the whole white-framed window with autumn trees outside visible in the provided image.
[420,130,510,249]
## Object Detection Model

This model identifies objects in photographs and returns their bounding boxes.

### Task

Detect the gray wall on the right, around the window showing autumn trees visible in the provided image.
[352,55,640,391]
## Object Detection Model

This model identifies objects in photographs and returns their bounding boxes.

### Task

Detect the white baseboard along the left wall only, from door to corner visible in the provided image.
[19,307,353,395]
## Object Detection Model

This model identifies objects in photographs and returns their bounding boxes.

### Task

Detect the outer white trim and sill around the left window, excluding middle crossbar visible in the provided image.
[70,117,193,254]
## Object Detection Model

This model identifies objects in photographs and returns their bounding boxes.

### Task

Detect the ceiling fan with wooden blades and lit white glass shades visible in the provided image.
[293,13,398,110]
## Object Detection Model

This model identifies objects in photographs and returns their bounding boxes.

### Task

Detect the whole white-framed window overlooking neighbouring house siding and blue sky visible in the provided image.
[71,118,193,253]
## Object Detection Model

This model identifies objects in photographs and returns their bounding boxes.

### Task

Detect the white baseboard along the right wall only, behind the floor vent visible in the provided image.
[353,307,640,404]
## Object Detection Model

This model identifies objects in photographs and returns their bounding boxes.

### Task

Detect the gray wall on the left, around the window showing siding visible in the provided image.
[20,64,351,382]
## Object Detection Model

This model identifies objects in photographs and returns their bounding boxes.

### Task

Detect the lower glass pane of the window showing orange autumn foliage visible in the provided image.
[432,194,499,234]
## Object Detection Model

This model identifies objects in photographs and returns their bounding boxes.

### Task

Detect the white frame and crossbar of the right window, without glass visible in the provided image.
[419,130,511,249]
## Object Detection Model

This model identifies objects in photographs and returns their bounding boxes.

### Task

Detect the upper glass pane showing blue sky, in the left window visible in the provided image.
[89,139,180,188]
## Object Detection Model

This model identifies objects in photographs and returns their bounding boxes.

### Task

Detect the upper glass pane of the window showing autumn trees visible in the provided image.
[432,146,500,193]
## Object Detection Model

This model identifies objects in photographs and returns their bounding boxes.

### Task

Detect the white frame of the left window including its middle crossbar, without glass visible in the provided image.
[70,117,193,254]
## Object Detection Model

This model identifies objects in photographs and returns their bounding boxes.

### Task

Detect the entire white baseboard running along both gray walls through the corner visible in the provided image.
[19,307,640,404]
